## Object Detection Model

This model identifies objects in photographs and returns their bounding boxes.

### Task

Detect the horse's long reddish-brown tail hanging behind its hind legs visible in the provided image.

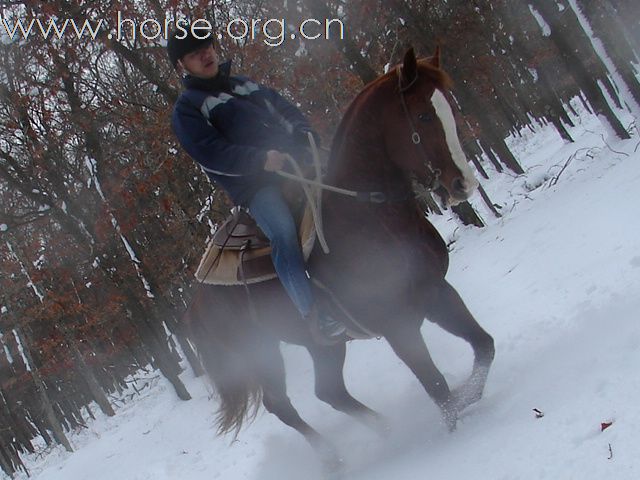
[185,286,264,435]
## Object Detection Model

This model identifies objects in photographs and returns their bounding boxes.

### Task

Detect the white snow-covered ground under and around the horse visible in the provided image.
[11,106,640,480]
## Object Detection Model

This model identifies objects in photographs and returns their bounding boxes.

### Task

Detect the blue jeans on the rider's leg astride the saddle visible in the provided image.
[249,186,314,316]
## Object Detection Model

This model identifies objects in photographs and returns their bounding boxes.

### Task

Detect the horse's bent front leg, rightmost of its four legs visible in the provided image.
[427,281,495,410]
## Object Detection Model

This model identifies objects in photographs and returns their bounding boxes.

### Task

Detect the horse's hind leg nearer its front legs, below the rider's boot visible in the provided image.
[307,343,388,435]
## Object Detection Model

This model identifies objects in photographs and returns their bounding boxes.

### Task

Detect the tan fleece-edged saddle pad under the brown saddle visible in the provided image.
[195,206,316,286]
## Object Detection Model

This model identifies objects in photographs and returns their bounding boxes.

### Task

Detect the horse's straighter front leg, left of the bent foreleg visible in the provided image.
[385,322,457,430]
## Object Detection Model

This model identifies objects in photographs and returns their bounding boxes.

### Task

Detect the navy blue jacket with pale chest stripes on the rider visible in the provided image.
[171,62,311,205]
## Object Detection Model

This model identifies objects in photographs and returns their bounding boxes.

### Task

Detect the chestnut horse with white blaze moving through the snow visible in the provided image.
[186,48,495,471]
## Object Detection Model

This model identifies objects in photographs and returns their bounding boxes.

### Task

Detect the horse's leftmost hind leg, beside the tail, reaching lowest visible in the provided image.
[260,343,342,473]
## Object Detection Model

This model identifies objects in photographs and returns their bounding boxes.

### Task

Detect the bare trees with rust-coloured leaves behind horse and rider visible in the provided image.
[0,0,640,476]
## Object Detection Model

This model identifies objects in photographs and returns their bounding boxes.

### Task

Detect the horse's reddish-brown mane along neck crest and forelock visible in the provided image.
[331,58,453,157]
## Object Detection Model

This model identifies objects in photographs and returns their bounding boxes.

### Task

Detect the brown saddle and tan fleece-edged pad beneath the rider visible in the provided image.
[195,202,315,286]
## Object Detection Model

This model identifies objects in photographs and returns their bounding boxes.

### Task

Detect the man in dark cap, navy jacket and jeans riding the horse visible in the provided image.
[167,26,345,345]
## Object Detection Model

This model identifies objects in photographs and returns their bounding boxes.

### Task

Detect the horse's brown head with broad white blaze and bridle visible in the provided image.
[383,48,478,205]
